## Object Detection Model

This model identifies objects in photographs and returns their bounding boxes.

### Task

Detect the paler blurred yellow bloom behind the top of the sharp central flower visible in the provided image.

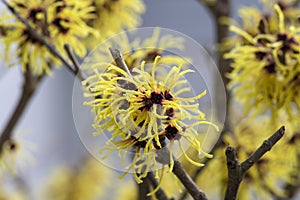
[80,28,190,74]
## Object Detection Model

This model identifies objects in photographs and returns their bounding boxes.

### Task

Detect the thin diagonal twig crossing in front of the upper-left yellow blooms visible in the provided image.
[1,0,76,75]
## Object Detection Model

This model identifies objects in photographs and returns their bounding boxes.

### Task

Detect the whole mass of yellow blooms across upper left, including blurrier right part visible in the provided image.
[0,0,144,75]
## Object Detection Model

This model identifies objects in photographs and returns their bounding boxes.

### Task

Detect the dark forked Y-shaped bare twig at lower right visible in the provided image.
[225,126,285,200]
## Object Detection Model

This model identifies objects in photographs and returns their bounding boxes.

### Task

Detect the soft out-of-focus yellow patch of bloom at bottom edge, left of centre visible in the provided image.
[42,158,111,200]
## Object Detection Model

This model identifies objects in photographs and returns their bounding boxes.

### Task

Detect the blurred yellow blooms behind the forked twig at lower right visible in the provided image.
[197,117,300,199]
